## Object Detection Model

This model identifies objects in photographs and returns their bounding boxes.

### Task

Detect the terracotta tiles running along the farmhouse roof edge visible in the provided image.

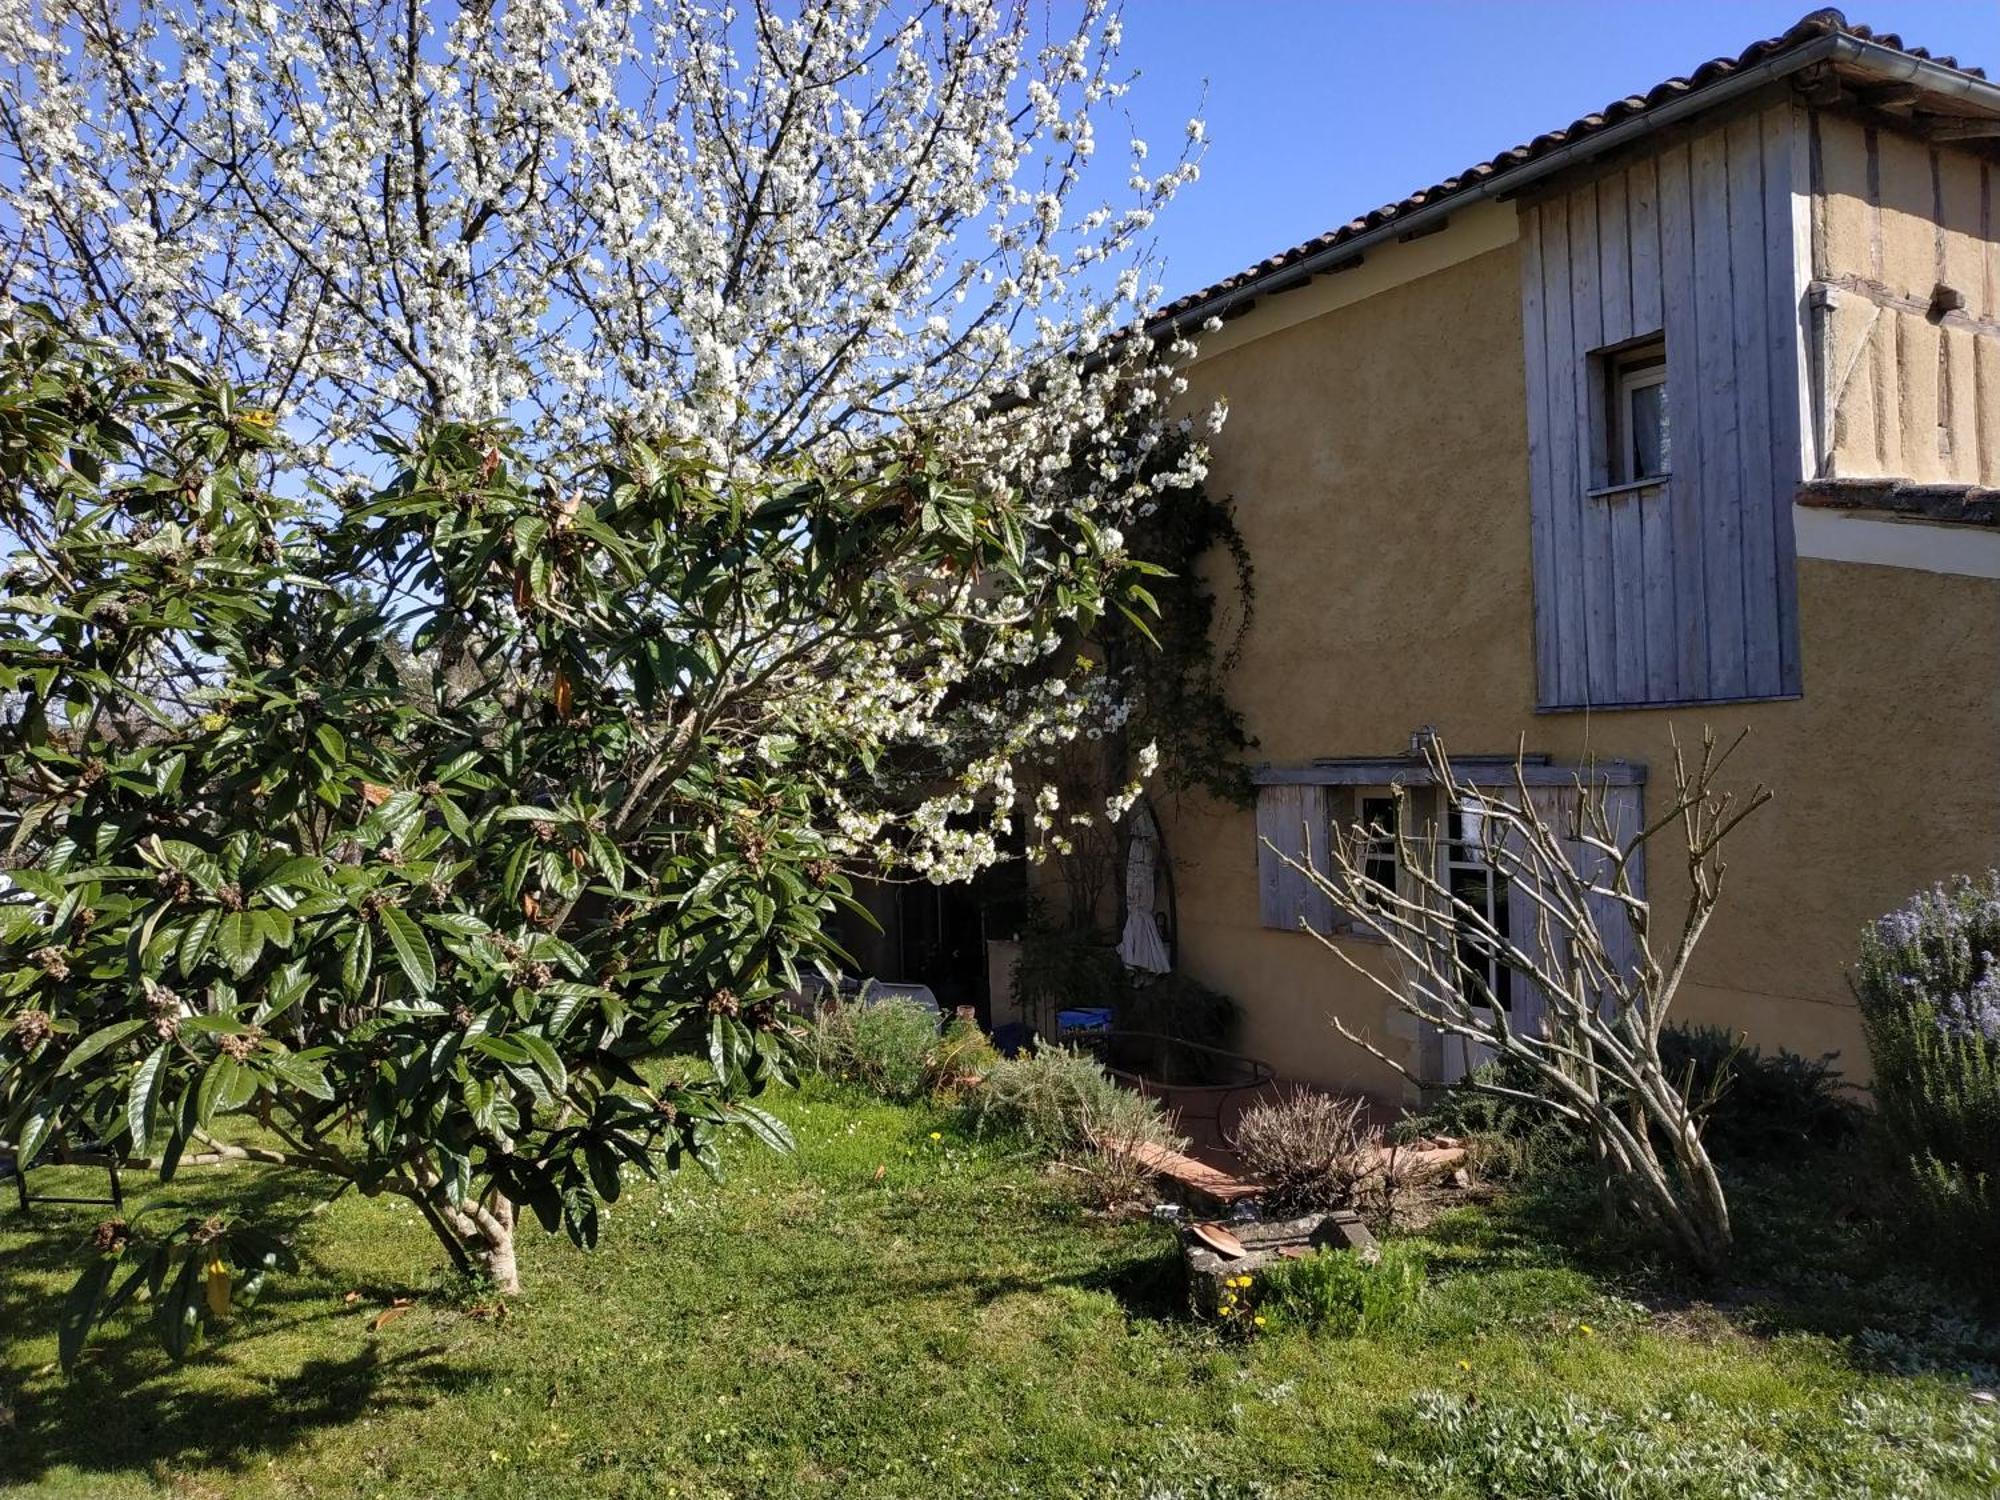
[1148,8,1986,326]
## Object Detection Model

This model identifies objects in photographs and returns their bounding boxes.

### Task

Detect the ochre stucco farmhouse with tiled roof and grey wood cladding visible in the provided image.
[1156,10,2000,1096]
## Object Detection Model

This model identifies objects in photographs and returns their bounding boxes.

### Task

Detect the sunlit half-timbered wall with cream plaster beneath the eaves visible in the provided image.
[1808,110,2000,486]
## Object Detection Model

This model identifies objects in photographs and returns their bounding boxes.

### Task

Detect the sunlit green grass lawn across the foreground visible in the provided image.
[0,1088,2000,1500]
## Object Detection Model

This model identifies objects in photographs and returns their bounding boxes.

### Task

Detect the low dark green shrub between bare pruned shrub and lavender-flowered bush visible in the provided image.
[1660,1026,1862,1160]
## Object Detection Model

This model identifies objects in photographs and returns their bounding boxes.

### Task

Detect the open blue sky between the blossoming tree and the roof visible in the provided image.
[1124,0,2000,296]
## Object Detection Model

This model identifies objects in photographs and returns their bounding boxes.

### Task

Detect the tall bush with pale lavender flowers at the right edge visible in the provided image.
[1854,870,2000,1256]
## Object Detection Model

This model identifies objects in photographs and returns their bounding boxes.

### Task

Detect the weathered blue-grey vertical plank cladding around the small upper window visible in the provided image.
[1522,102,1806,708]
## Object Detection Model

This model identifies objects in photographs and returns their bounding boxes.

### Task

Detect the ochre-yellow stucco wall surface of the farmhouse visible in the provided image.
[1160,236,2000,1096]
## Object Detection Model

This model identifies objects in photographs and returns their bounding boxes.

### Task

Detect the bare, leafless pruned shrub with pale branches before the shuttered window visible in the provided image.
[1304,732,1770,1276]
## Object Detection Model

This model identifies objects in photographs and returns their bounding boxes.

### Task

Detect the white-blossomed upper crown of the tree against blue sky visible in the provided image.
[0,0,1200,474]
